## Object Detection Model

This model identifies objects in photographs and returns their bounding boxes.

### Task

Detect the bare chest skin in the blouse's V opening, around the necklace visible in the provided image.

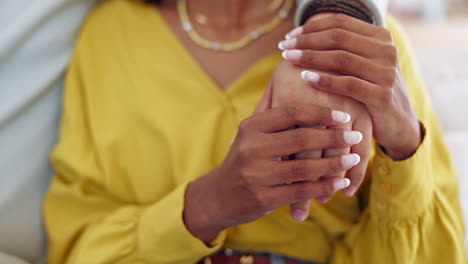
[159,0,294,90]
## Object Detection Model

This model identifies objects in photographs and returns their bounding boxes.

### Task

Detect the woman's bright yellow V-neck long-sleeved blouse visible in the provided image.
[45,0,466,264]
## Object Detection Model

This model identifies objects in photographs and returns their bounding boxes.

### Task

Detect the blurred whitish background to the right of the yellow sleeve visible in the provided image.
[390,0,468,250]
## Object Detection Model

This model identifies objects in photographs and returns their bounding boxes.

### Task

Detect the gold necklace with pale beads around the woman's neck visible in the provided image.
[177,0,294,52]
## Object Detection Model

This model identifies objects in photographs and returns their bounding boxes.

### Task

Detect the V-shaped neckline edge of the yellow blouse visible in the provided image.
[153,7,280,98]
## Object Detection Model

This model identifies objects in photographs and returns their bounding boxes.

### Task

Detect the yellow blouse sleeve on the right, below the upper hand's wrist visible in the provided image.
[331,18,467,264]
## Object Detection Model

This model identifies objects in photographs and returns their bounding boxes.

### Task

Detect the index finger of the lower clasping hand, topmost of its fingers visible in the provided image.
[250,104,351,133]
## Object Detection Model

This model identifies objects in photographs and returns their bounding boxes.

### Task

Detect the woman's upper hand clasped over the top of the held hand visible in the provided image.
[280,14,421,160]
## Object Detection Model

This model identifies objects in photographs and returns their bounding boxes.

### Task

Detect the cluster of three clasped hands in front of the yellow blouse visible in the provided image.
[184,14,421,242]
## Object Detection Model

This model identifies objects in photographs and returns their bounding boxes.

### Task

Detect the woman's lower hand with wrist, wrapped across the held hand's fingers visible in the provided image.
[184,102,359,242]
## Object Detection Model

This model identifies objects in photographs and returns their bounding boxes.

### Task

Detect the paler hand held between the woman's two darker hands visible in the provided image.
[269,61,372,221]
